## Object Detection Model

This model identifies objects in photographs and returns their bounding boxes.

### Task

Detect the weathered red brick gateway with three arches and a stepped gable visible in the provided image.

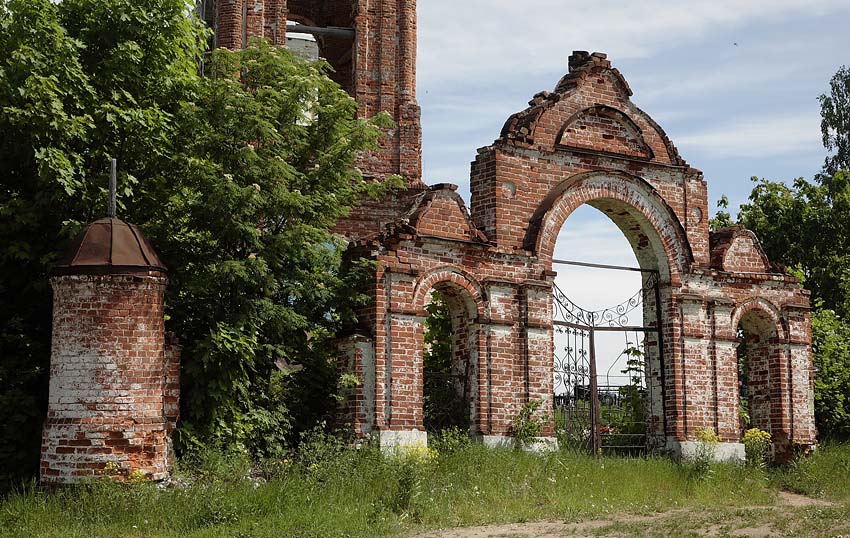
[332,52,815,458]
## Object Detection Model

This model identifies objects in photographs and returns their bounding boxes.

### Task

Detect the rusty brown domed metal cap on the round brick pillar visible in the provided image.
[54,217,166,275]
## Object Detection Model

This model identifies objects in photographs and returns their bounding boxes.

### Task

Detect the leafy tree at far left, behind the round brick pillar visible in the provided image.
[0,0,205,482]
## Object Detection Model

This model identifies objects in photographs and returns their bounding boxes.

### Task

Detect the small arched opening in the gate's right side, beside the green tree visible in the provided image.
[737,308,781,434]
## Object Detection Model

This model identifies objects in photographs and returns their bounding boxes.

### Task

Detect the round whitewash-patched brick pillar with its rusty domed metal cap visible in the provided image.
[40,219,173,483]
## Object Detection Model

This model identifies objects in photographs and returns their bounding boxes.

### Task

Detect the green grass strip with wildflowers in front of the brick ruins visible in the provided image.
[0,440,850,538]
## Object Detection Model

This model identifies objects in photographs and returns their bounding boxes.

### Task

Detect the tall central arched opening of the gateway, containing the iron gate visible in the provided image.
[544,184,671,454]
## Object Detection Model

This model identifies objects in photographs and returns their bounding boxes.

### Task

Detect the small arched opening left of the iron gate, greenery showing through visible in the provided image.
[422,282,478,434]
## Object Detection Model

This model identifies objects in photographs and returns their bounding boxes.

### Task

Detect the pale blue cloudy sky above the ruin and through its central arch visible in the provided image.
[417,0,850,376]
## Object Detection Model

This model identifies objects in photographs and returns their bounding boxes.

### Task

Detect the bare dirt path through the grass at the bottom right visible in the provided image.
[411,491,850,538]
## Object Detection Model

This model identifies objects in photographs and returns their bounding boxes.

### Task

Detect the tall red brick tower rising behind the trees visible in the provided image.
[198,0,424,191]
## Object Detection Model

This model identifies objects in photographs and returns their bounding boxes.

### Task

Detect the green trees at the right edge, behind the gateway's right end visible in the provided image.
[711,63,850,438]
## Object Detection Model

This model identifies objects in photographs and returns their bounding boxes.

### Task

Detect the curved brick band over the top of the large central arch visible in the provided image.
[524,172,693,279]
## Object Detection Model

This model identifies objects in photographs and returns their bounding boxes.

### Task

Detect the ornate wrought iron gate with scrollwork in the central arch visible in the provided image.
[553,260,664,454]
